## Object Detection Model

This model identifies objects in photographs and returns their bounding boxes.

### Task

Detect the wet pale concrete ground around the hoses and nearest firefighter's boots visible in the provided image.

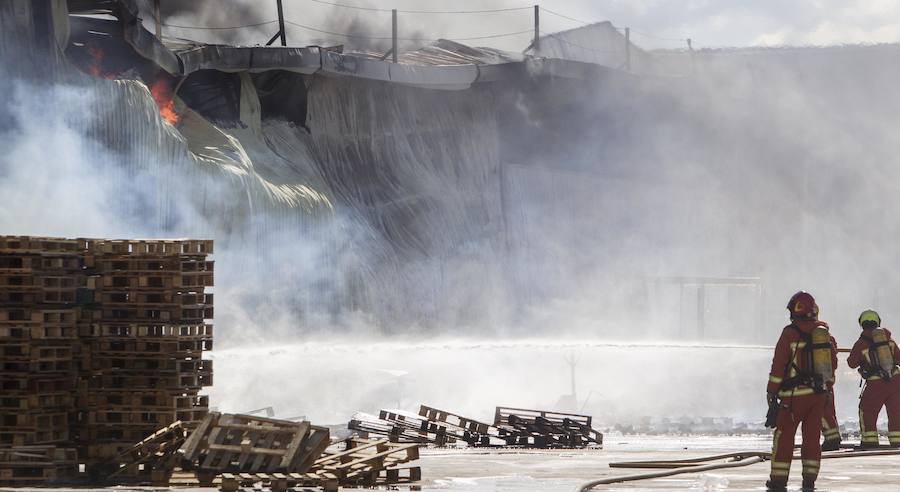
[419,436,900,492]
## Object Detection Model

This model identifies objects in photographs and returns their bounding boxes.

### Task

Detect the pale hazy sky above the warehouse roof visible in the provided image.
[145,0,900,50]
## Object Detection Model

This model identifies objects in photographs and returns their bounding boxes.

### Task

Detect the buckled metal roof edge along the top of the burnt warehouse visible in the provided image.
[68,0,624,90]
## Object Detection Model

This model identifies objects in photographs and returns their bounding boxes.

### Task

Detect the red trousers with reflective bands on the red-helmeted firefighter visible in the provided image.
[770,393,828,483]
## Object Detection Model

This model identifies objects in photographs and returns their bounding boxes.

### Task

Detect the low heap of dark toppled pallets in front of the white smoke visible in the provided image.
[348,405,603,448]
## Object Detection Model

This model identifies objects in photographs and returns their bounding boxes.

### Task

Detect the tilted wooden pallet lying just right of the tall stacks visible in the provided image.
[181,412,330,473]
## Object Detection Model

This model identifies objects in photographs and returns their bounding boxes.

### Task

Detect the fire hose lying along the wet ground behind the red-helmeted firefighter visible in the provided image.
[575,448,900,492]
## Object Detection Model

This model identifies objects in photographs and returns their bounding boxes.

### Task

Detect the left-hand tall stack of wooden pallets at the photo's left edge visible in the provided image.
[0,236,87,460]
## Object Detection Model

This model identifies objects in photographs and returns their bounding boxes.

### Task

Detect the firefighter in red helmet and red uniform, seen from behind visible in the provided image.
[766,292,837,491]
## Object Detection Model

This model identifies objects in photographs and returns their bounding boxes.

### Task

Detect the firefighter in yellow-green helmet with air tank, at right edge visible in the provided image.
[847,309,900,448]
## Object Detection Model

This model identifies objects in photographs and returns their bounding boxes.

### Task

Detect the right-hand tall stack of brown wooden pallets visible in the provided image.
[79,240,213,461]
